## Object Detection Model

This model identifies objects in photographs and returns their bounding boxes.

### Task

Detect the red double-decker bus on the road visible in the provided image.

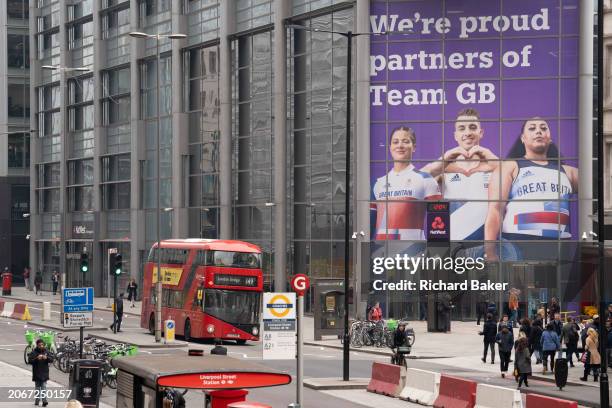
[140,239,263,344]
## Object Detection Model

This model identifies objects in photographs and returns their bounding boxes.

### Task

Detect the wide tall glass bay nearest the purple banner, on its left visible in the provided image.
[287,9,353,310]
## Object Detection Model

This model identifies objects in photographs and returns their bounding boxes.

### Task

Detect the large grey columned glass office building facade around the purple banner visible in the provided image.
[25,0,608,318]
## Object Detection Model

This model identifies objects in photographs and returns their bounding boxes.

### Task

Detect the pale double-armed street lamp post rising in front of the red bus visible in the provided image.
[130,31,187,343]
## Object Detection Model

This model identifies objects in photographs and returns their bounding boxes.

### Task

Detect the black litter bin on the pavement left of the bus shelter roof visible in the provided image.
[69,359,104,408]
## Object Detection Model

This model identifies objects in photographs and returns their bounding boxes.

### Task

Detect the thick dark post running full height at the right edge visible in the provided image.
[597,0,610,407]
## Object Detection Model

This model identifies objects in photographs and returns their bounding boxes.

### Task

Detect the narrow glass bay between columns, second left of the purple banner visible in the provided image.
[232,31,274,285]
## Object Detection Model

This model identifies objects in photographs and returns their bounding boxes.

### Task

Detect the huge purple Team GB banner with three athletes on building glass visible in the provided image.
[369,0,579,255]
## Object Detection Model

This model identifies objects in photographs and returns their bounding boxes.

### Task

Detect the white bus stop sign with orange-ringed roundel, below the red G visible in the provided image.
[262,293,296,360]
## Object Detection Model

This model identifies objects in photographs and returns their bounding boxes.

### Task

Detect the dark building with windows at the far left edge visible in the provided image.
[0,0,31,282]
